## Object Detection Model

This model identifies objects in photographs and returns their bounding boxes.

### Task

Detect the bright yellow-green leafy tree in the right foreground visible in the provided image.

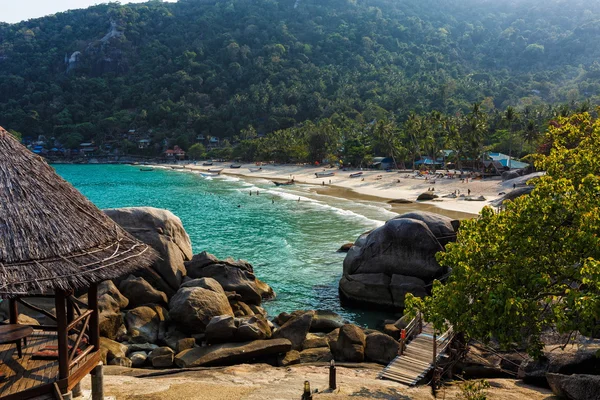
[407,113,600,355]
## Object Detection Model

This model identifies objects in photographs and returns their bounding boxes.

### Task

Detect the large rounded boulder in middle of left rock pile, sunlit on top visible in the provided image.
[169,278,233,333]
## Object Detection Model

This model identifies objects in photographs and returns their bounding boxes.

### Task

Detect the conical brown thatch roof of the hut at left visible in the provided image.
[0,127,157,298]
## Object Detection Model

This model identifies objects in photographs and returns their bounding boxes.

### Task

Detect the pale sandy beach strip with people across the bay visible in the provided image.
[155,162,506,219]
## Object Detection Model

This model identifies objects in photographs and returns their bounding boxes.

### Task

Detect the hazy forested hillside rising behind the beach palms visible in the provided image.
[0,0,600,153]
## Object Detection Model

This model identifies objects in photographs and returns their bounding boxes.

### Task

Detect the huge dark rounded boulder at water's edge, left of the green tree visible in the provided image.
[339,212,459,308]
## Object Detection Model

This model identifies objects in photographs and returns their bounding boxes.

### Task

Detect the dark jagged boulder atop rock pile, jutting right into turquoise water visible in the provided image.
[185,251,275,305]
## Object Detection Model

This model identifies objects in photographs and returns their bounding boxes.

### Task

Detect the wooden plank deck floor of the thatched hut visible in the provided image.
[0,331,99,400]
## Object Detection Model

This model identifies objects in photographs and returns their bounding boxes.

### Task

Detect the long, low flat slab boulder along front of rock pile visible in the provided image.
[175,339,292,368]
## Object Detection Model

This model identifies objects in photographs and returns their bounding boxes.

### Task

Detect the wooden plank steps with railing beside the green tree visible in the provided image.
[379,324,451,386]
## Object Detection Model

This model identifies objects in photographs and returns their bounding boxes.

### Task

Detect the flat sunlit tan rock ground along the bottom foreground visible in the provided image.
[79,364,553,400]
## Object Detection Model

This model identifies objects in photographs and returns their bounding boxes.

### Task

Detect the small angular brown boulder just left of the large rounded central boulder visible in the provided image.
[125,306,167,343]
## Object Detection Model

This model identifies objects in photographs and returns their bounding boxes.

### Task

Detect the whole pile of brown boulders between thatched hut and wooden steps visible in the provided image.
[16,208,399,368]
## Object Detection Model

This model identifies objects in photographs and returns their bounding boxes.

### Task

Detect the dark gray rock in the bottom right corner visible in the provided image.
[546,373,600,400]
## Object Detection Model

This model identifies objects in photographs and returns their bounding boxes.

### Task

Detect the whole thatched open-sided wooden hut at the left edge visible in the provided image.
[0,127,157,400]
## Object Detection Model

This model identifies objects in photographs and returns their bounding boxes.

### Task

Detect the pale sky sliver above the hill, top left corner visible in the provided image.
[0,0,176,23]
